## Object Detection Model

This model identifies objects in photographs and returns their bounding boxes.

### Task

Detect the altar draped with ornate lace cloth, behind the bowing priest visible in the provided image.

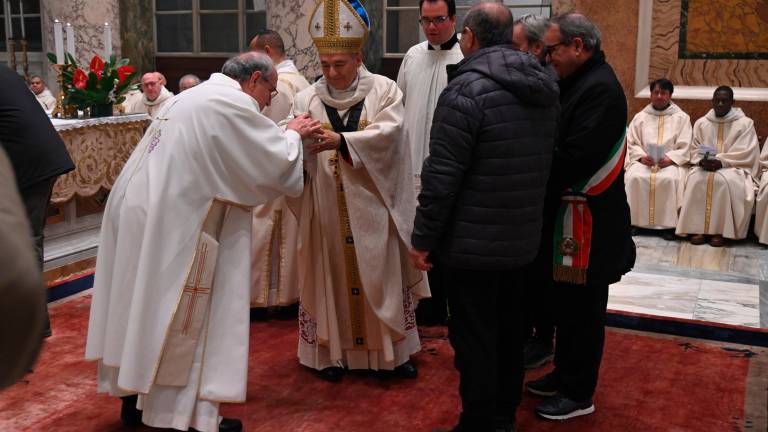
[44,114,151,270]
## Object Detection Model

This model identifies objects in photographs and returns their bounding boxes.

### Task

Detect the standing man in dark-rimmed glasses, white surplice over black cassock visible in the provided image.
[397,0,464,325]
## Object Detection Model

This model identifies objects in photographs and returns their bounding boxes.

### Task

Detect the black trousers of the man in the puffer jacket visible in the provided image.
[443,268,526,432]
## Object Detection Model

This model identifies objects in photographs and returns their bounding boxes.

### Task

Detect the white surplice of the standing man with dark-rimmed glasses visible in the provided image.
[397,41,464,193]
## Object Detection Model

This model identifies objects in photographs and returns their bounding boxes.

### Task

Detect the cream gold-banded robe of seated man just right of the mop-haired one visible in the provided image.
[676,108,760,239]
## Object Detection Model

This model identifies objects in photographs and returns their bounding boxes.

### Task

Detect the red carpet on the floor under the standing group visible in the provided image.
[0,296,768,432]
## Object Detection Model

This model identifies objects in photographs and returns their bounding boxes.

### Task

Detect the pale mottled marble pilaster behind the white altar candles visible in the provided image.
[40,0,121,64]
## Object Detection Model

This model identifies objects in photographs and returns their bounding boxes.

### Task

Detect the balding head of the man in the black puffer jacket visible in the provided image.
[464,2,514,48]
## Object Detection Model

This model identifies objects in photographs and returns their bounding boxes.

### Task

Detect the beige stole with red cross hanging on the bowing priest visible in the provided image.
[155,199,228,387]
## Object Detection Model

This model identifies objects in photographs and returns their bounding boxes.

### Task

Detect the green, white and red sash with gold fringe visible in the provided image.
[552,129,627,285]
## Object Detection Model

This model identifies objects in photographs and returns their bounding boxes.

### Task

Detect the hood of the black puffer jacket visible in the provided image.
[448,45,560,106]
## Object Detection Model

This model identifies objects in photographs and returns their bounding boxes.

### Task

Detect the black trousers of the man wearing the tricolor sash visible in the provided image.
[553,283,608,401]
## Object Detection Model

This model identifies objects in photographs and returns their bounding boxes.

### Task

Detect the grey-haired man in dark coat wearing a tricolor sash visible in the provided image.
[527,13,635,420]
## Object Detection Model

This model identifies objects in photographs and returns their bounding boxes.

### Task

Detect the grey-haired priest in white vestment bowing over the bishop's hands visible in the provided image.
[86,53,320,432]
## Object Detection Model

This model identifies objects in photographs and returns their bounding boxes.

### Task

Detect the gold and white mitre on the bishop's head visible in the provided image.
[309,0,371,54]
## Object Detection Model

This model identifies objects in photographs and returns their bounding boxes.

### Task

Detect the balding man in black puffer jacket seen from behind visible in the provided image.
[411,3,559,432]
